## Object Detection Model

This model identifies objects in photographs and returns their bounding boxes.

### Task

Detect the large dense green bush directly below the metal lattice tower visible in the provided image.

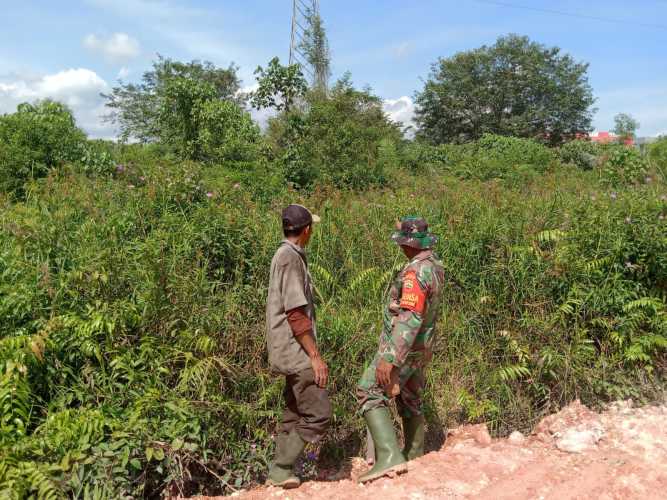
[268,77,401,189]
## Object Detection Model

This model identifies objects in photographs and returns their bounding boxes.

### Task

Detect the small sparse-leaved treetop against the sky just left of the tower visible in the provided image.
[250,57,308,112]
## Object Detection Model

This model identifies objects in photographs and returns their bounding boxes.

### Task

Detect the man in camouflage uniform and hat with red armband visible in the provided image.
[357,217,444,482]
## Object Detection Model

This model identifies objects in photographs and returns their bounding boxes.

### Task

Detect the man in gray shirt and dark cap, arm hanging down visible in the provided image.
[266,205,331,488]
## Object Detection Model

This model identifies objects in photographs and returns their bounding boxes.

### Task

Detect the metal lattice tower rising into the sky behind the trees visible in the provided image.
[289,0,329,88]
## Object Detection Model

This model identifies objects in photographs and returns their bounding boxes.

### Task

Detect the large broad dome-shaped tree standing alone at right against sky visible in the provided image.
[415,35,595,145]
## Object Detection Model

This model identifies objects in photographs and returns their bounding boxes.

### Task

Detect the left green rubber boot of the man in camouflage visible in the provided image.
[359,408,408,483]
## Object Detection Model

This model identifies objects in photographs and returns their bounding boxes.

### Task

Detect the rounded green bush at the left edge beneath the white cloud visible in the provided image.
[0,100,85,196]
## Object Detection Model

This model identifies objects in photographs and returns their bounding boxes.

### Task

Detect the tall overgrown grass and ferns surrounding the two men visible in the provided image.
[0,157,667,498]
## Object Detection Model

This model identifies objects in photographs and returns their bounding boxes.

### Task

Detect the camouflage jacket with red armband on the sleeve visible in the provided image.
[379,250,445,367]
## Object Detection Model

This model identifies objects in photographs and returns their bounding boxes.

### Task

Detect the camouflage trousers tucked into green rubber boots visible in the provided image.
[357,352,425,418]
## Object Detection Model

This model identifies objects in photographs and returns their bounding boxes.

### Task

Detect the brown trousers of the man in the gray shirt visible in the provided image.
[279,368,331,443]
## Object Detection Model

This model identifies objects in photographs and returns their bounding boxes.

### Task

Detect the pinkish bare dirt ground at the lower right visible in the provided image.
[204,402,667,500]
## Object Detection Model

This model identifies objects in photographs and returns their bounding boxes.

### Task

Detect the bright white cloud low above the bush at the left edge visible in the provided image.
[0,68,115,138]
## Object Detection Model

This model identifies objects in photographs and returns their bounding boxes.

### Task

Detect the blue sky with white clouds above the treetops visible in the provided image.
[0,0,667,138]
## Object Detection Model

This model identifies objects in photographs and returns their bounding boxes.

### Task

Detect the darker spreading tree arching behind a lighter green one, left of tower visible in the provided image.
[102,56,241,142]
